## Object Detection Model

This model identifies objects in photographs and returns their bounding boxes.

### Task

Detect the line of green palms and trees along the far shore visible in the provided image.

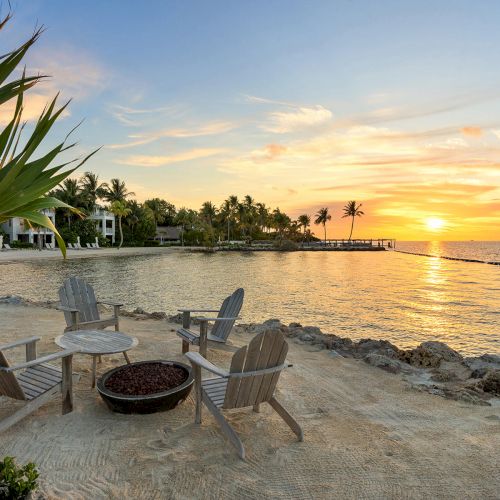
[52,172,363,246]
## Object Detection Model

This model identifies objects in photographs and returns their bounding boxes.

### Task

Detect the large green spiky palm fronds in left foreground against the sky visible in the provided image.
[0,14,96,257]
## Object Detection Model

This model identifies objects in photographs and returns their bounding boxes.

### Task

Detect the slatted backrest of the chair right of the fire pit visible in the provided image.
[222,330,288,409]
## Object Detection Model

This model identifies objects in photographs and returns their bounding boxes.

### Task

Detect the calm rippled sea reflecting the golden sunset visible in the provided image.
[0,242,500,354]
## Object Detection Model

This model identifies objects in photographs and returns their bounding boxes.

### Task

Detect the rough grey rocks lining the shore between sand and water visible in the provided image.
[0,295,500,406]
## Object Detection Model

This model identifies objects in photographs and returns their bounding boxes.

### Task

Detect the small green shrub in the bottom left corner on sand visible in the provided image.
[0,457,39,500]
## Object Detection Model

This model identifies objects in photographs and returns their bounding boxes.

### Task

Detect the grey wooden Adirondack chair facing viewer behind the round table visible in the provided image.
[57,277,123,332]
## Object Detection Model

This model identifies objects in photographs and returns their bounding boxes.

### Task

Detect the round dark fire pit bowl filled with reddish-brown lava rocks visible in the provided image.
[97,360,194,413]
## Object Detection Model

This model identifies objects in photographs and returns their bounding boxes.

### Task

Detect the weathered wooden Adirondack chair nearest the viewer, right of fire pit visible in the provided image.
[186,331,304,458]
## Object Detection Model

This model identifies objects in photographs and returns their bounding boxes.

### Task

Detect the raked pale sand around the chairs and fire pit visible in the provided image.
[0,302,500,499]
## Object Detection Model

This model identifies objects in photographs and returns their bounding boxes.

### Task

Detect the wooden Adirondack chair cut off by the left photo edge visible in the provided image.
[0,337,78,432]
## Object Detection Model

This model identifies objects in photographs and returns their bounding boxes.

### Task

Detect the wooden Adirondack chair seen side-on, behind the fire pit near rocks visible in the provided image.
[177,288,245,357]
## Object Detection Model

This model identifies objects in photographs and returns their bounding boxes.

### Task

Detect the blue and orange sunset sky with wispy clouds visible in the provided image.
[0,0,500,240]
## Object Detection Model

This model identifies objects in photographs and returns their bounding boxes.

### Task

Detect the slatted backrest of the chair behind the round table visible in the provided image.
[59,276,101,326]
